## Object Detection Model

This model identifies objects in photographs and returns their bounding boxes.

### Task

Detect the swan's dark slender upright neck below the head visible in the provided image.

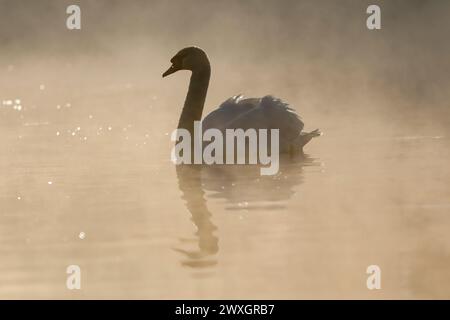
[178,63,211,134]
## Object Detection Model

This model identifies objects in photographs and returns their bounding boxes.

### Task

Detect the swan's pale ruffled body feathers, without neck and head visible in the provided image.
[202,95,303,152]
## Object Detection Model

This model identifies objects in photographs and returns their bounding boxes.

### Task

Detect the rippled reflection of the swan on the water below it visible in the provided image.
[174,155,320,268]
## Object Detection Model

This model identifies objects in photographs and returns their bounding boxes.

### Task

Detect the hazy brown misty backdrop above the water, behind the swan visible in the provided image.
[0,0,450,127]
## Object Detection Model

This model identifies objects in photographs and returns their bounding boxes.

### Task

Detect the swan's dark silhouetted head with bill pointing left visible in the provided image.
[163,47,209,78]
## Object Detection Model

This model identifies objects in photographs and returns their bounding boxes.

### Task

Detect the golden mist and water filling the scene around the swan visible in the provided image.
[0,0,450,299]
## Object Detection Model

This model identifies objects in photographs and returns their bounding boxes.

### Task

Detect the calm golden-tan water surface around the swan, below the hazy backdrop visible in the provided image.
[0,62,450,299]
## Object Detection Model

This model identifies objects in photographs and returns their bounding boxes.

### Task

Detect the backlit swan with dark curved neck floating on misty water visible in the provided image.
[162,46,322,154]
